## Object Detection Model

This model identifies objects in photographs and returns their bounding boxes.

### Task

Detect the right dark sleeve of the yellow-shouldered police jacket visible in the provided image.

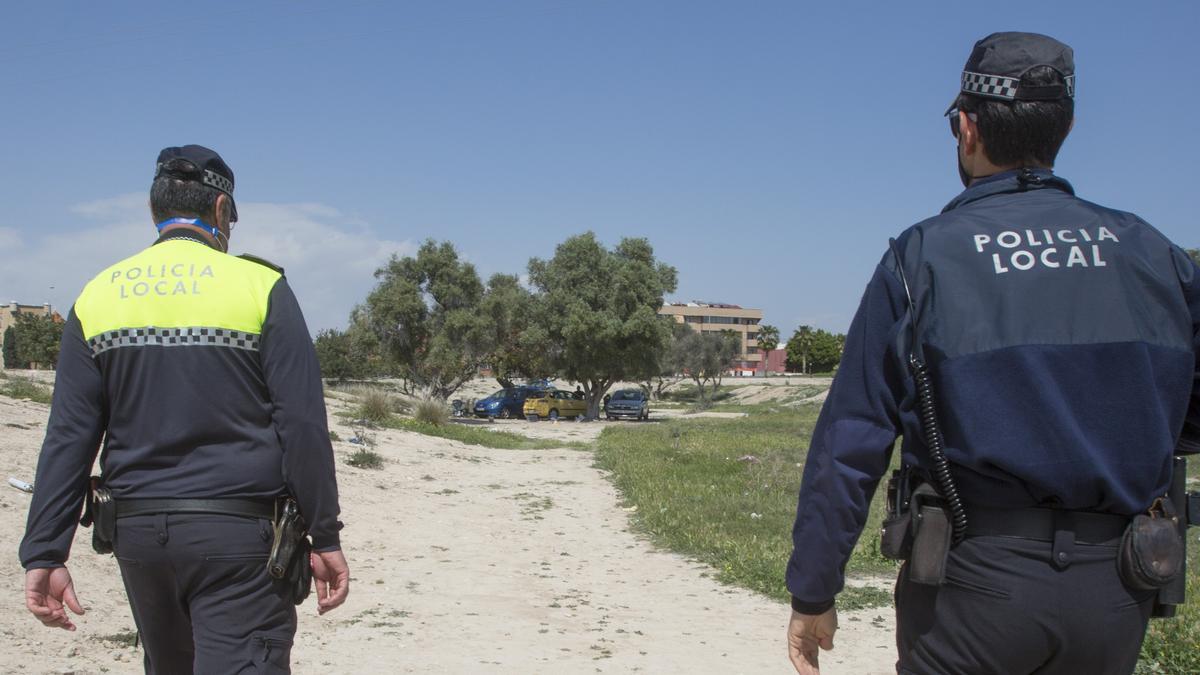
[259,277,342,551]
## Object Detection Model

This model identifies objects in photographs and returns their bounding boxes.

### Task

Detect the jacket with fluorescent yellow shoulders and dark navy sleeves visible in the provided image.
[20,231,341,568]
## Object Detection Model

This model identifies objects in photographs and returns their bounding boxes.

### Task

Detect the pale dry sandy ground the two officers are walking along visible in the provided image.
[0,381,894,674]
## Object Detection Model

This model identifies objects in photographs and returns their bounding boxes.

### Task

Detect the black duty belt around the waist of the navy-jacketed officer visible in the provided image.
[966,506,1130,545]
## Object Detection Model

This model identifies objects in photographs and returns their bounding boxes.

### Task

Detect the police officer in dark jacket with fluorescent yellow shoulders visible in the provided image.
[20,145,349,674]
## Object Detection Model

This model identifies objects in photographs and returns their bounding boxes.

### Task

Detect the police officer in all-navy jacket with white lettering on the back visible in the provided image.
[787,32,1200,674]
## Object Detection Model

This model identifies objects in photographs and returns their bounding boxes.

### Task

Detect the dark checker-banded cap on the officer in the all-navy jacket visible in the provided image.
[952,32,1075,108]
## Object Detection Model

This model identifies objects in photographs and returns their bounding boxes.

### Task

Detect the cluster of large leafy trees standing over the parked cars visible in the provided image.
[316,232,676,417]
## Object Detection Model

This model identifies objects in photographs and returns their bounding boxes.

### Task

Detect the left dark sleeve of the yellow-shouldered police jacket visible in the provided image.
[20,309,108,569]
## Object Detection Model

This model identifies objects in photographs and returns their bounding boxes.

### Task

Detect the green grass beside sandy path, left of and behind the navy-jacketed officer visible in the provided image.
[596,406,896,607]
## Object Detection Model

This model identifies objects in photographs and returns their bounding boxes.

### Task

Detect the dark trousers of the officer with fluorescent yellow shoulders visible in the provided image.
[114,514,296,675]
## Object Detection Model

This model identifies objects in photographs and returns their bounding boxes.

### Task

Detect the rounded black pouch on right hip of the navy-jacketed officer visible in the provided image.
[1117,498,1184,591]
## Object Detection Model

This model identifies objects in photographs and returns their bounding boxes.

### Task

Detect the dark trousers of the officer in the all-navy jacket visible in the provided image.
[895,536,1154,675]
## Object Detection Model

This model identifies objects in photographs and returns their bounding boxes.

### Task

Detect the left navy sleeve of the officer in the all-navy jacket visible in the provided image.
[787,260,904,614]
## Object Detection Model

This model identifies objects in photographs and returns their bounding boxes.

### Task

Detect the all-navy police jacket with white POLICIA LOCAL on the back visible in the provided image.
[787,171,1200,614]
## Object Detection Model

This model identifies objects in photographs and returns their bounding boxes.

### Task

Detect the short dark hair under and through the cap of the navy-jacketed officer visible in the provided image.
[958,66,1075,167]
